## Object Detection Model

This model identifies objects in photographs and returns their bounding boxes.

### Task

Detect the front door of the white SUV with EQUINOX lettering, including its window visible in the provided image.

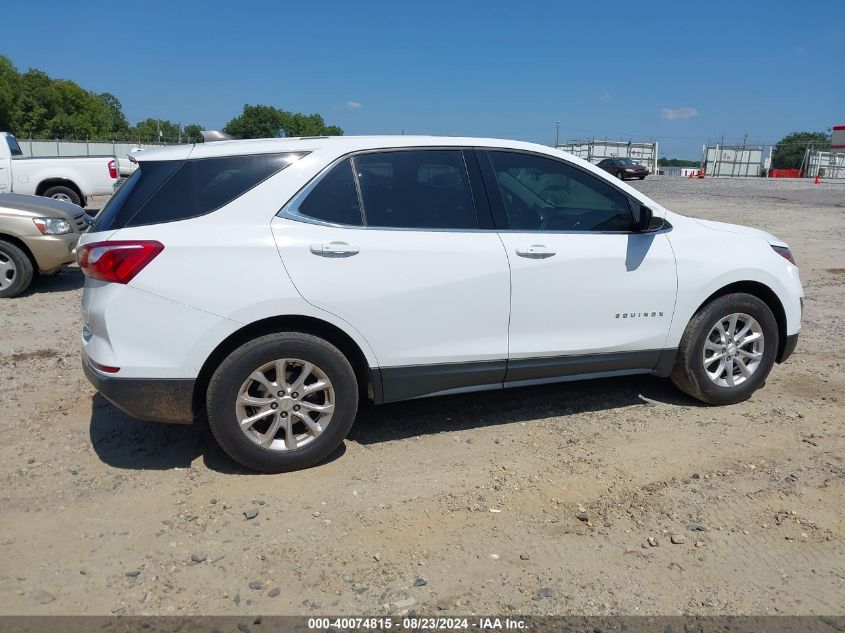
[479,151,677,382]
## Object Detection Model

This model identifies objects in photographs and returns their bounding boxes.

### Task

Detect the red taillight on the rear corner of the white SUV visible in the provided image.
[77,240,164,284]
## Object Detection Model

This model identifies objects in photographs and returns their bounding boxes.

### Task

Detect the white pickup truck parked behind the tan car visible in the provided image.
[0,132,120,207]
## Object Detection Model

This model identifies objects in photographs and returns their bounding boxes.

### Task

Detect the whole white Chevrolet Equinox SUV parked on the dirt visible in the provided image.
[79,136,803,471]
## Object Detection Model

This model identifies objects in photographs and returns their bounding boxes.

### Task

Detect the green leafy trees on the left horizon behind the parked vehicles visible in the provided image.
[0,55,343,143]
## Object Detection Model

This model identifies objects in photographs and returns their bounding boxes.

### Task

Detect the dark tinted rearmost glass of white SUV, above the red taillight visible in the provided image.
[92,153,303,231]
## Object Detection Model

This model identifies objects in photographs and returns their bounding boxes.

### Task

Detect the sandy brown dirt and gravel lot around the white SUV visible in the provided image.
[0,178,845,615]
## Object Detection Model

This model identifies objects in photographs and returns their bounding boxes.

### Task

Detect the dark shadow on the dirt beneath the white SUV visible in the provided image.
[89,376,704,474]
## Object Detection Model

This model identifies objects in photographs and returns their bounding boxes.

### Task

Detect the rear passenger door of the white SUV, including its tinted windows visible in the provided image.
[273,149,510,400]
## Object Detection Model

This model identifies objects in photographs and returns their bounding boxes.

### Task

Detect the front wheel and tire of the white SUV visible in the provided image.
[672,293,778,405]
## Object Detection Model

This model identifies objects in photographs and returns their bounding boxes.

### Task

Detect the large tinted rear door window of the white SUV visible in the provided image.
[354,150,478,229]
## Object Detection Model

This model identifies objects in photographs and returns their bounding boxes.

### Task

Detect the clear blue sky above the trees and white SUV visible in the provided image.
[0,0,845,158]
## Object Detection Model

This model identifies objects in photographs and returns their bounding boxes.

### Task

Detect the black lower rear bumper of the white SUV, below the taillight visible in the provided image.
[82,354,195,424]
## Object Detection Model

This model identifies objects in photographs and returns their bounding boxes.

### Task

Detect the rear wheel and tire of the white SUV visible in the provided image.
[206,332,358,473]
